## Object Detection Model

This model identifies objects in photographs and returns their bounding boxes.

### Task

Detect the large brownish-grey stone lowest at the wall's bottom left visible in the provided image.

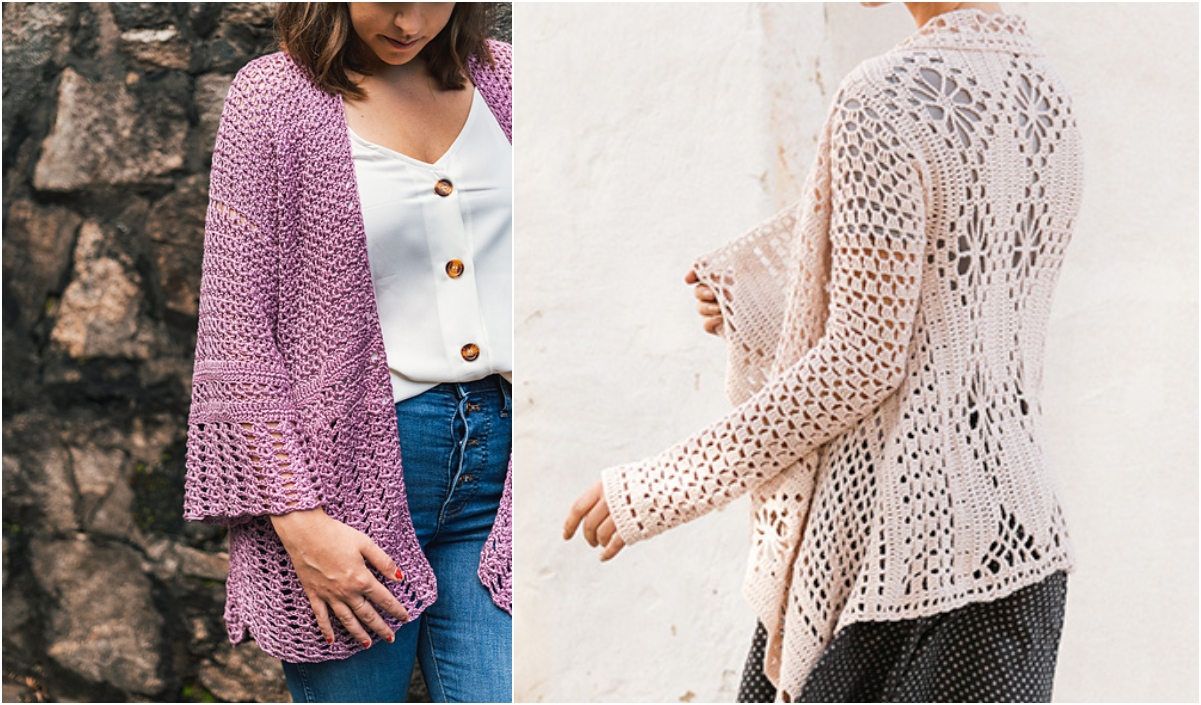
[30,538,166,694]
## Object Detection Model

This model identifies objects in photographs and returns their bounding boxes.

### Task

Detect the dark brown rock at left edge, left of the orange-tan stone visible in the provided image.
[4,201,82,329]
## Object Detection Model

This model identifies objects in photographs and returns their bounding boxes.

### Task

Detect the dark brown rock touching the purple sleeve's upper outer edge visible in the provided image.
[145,174,209,316]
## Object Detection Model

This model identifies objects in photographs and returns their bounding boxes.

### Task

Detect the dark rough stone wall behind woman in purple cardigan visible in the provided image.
[2,2,509,701]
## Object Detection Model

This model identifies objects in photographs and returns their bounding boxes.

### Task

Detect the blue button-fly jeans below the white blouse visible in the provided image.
[283,375,513,703]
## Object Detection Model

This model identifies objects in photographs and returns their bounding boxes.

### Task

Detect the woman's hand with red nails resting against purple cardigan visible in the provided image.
[271,507,408,646]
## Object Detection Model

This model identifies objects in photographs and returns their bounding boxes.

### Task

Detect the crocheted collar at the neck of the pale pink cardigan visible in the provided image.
[896,8,1042,54]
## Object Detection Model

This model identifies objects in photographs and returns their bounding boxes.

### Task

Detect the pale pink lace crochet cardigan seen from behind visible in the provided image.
[603,10,1083,700]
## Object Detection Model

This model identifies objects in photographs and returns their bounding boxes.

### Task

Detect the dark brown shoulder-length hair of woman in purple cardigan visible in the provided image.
[275,2,495,100]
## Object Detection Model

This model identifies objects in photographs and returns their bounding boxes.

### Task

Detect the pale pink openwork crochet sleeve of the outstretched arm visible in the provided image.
[603,84,926,544]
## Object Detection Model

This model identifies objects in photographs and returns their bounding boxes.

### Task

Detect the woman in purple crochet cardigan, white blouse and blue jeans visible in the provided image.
[185,2,512,701]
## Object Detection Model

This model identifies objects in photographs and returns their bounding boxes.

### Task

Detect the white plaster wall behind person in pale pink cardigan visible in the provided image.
[514,4,1197,701]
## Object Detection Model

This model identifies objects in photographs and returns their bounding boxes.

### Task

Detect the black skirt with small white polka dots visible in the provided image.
[739,572,1068,703]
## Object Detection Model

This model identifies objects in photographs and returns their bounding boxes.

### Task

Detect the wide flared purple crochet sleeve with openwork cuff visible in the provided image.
[184,66,321,522]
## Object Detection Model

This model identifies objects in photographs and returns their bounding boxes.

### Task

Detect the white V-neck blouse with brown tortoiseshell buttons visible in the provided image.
[347,90,513,401]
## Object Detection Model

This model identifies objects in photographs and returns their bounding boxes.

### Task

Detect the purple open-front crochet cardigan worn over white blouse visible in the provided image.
[184,42,513,662]
